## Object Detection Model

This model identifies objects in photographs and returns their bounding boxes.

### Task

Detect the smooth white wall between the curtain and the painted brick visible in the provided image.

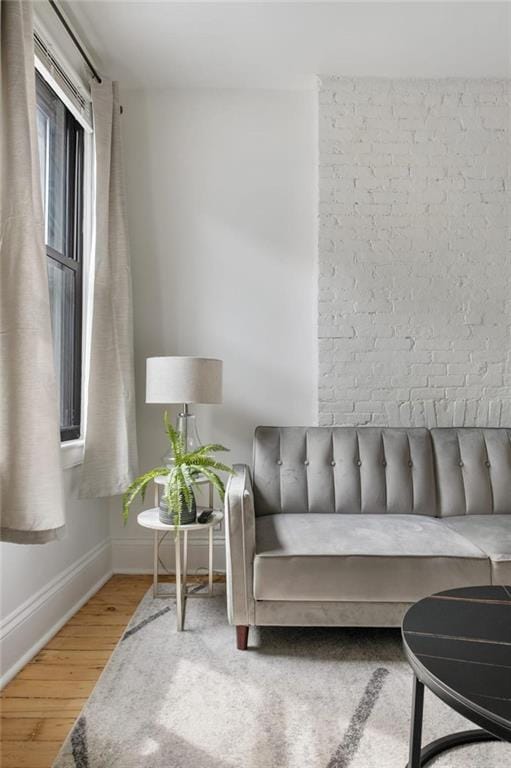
[112,89,317,570]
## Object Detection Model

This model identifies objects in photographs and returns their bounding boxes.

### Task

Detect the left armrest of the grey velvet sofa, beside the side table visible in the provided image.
[225,464,255,625]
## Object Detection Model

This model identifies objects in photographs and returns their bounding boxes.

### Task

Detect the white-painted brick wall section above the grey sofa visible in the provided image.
[318,78,511,426]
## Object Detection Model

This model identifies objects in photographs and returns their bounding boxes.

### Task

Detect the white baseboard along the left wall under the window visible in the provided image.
[0,539,112,688]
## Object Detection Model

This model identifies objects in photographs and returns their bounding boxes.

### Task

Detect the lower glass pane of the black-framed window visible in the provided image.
[48,258,76,428]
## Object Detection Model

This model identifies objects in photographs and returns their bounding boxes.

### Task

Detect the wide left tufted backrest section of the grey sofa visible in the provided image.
[253,427,437,516]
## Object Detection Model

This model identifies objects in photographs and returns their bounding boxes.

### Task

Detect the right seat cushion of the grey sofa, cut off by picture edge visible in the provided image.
[445,515,511,585]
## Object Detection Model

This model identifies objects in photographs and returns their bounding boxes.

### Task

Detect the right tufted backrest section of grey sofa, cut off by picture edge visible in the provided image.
[431,427,511,517]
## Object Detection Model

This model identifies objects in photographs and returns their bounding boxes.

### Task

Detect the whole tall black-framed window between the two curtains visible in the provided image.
[36,73,84,441]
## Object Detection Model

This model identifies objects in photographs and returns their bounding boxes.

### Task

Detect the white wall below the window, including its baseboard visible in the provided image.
[0,467,111,685]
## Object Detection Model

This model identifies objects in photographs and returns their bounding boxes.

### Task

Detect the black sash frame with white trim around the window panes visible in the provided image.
[35,73,88,446]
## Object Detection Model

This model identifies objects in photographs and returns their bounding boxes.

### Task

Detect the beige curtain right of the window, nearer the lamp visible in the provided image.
[80,80,137,497]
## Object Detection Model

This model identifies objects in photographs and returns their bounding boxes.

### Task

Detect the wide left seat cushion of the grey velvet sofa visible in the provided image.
[254,514,491,602]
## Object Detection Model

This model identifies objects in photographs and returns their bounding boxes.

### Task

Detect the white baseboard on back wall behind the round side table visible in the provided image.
[112,537,225,573]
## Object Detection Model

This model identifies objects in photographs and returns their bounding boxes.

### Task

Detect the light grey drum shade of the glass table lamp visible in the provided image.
[146,357,223,404]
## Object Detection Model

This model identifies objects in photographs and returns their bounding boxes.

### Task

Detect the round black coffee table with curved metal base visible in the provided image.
[402,586,511,768]
